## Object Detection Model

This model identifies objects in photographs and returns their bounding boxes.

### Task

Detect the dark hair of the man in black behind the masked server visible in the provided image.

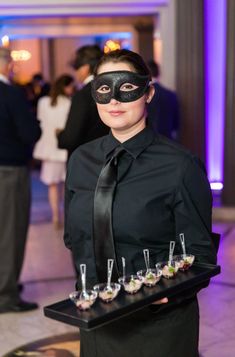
[70,45,103,74]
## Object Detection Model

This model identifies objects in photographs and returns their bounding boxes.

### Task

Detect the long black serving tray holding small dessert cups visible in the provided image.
[44,263,220,330]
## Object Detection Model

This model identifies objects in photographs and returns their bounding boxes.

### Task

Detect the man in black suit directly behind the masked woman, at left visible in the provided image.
[58,45,109,156]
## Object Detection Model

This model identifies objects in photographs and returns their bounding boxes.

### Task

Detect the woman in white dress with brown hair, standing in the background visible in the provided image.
[33,74,75,229]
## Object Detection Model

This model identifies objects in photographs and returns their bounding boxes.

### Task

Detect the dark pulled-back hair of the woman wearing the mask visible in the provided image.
[95,49,151,79]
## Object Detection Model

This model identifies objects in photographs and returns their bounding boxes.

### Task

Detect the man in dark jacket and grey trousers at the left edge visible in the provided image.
[0,47,41,313]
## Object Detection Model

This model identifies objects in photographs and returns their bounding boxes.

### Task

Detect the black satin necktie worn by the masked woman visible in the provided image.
[93,146,125,282]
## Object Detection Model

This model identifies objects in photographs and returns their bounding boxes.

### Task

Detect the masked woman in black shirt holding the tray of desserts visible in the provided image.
[64,50,216,357]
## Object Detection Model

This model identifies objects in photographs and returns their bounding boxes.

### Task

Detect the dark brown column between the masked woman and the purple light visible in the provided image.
[176,0,205,161]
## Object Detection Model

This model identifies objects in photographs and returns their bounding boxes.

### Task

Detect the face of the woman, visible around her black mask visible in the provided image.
[97,62,154,140]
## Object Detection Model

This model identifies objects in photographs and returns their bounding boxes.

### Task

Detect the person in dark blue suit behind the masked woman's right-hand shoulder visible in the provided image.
[148,60,180,140]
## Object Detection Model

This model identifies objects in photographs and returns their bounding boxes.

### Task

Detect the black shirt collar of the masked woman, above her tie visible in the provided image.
[104,126,155,159]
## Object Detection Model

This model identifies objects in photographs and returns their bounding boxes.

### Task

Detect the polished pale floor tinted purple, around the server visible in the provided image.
[0,173,235,357]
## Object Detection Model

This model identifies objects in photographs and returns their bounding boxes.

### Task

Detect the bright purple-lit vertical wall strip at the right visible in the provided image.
[204,0,226,189]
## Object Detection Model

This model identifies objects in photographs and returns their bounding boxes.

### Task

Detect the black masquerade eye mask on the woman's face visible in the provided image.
[91,71,150,104]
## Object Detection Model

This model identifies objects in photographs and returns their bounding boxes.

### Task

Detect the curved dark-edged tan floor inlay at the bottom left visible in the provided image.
[3,333,80,357]
